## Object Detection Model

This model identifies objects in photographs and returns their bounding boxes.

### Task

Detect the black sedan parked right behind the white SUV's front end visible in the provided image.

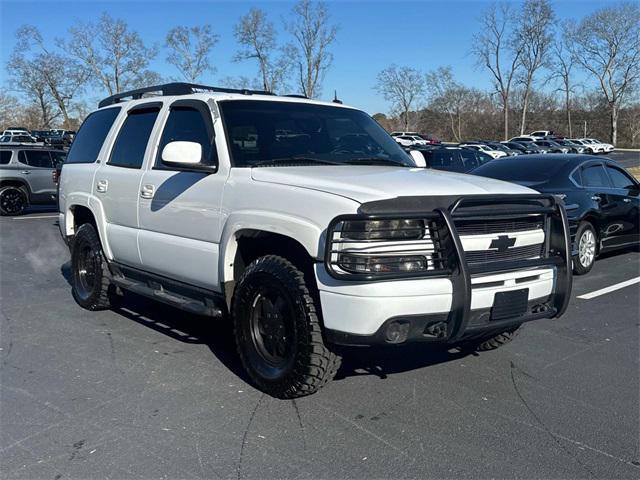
[471,154,640,275]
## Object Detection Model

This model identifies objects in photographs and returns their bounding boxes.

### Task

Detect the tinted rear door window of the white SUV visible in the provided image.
[109,109,158,168]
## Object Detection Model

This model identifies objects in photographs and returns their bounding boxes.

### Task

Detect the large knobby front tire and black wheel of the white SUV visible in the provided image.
[232,255,340,399]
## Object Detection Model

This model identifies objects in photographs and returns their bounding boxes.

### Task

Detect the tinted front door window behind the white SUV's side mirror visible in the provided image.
[158,107,215,164]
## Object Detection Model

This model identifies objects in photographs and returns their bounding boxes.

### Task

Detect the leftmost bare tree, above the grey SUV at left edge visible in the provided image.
[16,25,89,128]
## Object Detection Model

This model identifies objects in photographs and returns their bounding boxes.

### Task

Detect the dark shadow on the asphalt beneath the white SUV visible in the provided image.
[60,262,476,383]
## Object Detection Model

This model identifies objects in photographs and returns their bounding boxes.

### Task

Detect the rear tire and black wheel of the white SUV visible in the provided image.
[71,223,116,311]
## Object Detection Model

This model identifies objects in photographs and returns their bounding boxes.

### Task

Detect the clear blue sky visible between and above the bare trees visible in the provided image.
[0,0,611,114]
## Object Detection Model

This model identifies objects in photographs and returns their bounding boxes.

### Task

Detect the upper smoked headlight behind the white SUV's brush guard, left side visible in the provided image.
[340,219,425,240]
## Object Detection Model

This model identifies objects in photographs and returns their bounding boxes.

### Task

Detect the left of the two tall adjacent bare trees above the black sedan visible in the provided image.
[472,3,522,140]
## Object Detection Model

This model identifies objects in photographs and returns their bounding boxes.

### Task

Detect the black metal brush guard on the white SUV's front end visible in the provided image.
[325,194,573,345]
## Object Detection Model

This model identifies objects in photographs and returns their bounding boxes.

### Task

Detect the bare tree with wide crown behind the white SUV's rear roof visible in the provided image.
[60,13,157,95]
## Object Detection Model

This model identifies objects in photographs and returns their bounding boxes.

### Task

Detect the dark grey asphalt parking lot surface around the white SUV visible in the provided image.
[0,153,640,480]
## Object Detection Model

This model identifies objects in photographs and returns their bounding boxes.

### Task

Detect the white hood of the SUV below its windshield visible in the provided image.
[251,166,537,203]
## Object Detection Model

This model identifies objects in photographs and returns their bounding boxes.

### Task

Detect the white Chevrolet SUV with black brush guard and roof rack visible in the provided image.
[59,84,571,398]
